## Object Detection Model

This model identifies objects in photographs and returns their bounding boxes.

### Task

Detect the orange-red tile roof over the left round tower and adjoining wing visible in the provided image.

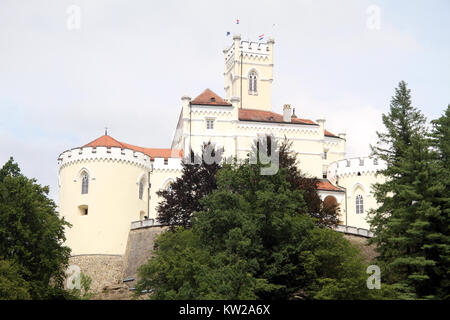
[83,135,183,159]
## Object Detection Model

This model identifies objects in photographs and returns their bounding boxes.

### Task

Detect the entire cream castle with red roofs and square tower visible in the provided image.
[58,35,383,255]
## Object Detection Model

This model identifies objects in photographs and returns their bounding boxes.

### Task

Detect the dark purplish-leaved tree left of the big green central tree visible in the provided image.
[156,143,223,229]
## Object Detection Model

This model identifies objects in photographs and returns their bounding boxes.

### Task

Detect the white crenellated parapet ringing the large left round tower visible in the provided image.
[58,147,153,170]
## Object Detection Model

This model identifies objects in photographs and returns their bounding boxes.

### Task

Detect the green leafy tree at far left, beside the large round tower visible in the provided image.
[0,158,70,299]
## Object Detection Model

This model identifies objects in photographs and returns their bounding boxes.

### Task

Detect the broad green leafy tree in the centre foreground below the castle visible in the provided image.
[137,162,386,299]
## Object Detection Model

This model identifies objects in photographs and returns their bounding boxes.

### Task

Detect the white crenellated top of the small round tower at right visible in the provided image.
[327,157,386,181]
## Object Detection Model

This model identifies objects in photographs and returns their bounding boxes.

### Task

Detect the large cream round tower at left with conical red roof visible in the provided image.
[58,135,151,255]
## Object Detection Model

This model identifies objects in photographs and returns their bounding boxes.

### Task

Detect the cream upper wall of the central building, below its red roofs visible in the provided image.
[178,100,345,178]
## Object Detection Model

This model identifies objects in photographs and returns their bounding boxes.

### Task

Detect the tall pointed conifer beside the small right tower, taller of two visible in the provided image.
[370,81,448,298]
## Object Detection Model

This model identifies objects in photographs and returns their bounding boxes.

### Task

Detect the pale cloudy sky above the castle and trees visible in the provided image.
[0,0,450,201]
